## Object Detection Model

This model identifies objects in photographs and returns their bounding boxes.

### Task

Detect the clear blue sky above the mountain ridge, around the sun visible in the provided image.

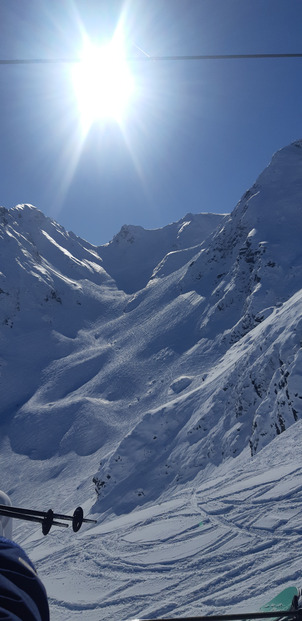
[0,0,302,245]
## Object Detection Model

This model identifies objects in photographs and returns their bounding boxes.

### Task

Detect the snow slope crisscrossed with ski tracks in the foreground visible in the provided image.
[11,421,302,621]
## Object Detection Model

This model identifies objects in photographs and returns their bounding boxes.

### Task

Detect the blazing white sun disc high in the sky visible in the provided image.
[72,41,134,133]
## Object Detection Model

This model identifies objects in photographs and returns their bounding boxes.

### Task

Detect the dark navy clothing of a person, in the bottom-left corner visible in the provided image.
[0,537,49,621]
